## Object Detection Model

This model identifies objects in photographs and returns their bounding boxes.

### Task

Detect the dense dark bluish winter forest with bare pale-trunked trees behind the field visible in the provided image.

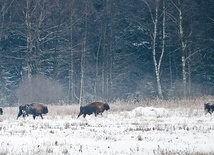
[0,0,214,106]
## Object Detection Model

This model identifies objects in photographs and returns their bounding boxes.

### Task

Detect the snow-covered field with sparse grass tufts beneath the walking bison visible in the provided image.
[0,103,214,155]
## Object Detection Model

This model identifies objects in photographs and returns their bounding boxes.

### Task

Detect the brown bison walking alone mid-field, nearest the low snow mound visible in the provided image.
[77,102,110,118]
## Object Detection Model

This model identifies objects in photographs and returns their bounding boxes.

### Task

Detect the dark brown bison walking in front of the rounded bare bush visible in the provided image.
[17,103,48,119]
